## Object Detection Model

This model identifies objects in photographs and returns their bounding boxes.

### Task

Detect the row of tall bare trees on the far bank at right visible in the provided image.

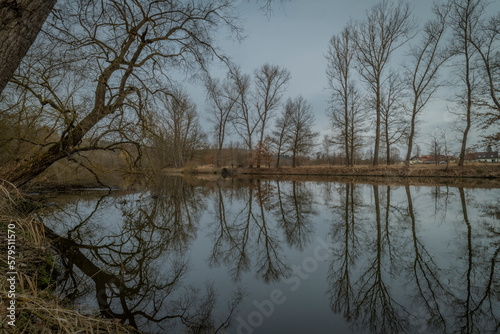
[326,0,500,166]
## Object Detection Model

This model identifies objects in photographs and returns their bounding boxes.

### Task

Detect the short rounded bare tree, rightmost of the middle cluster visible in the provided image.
[286,96,318,167]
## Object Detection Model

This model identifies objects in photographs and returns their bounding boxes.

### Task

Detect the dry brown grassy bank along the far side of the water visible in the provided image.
[17,163,500,192]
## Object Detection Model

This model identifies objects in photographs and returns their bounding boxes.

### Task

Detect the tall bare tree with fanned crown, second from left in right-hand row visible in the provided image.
[350,0,413,166]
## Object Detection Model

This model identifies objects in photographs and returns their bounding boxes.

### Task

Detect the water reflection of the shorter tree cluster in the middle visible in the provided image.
[210,179,315,282]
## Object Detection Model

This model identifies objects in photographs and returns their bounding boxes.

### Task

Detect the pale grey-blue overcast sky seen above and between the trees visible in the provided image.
[188,0,500,157]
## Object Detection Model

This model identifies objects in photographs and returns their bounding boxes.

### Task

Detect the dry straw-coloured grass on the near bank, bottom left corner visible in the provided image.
[0,186,137,333]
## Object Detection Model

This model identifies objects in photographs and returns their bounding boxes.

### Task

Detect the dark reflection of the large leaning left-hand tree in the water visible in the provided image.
[47,179,242,333]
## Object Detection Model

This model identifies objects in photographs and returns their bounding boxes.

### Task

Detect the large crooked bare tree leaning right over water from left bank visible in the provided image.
[4,0,243,186]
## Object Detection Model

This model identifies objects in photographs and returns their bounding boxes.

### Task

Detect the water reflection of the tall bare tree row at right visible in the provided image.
[328,184,500,333]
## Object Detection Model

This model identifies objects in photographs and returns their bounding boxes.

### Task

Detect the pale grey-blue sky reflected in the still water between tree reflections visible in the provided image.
[46,181,500,333]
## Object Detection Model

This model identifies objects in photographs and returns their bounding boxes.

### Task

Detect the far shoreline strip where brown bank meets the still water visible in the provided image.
[15,164,500,195]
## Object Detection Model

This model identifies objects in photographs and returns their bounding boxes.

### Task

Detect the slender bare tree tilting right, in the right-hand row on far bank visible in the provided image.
[405,5,451,166]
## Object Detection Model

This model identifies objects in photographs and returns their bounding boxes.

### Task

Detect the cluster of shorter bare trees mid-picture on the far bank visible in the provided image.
[206,64,316,167]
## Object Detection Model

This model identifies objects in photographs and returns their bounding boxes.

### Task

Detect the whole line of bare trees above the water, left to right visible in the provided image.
[0,0,500,185]
